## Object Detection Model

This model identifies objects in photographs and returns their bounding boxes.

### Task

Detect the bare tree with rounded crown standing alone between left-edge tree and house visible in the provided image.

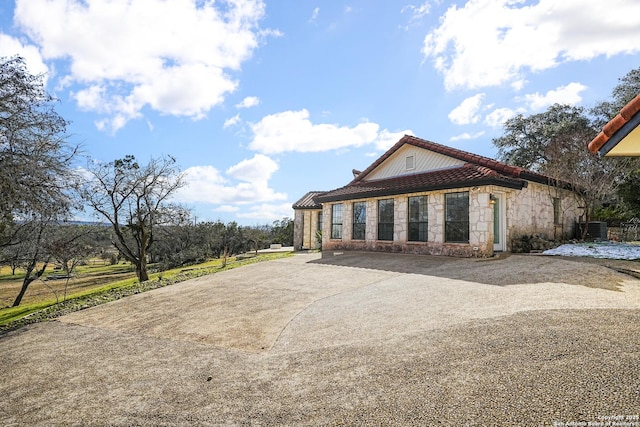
[82,156,189,282]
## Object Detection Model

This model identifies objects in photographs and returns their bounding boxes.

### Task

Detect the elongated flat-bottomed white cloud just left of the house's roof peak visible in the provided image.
[249,109,411,154]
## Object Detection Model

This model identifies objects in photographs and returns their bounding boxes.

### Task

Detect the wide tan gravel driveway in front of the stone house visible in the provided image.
[0,253,640,426]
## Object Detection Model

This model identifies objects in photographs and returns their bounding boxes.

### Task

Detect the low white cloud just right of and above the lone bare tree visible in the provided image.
[176,154,287,206]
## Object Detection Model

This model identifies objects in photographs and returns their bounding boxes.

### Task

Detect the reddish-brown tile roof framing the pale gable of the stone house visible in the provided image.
[315,135,551,203]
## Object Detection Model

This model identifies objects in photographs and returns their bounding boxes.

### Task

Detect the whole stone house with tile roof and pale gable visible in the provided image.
[293,135,581,257]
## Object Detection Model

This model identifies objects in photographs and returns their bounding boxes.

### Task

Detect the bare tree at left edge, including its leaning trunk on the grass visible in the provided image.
[0,57,77,306]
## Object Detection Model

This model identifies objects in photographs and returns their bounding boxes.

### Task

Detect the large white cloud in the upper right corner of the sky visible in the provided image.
[423,0,640,89]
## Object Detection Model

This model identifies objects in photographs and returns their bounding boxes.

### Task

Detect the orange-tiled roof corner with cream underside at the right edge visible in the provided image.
[589,94,640,157]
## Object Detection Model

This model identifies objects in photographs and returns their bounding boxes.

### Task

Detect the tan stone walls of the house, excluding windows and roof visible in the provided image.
[322,182,578,257]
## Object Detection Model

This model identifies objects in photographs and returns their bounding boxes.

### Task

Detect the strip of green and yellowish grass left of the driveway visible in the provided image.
[0,252,292,332]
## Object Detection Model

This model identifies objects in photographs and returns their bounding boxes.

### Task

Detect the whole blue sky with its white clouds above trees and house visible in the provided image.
[0,0,640,225]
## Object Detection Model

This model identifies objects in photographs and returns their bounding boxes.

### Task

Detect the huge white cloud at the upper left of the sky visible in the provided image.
[14,0,275,131]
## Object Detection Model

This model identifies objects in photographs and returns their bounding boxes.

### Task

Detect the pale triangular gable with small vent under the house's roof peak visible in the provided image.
[362,144,465,181]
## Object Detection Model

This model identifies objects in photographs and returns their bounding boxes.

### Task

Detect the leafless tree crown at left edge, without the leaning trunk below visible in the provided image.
[0,57,77,246]
